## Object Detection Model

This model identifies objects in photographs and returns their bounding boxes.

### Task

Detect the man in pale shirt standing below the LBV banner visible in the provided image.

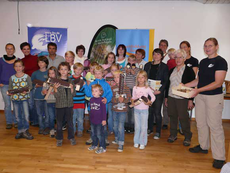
[47,42,65,69]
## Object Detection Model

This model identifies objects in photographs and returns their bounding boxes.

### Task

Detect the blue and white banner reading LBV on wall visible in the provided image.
[28,27,67,56]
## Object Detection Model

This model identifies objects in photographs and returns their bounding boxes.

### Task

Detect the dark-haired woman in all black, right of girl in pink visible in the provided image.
[144,48,168,139]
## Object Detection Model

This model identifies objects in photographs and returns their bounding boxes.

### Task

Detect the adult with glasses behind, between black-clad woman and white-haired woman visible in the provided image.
[159,39,169,130]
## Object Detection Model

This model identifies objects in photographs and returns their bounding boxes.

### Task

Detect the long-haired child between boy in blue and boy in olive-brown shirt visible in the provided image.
[42,66,58,138]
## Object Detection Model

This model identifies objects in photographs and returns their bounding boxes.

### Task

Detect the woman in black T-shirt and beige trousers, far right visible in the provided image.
[186,38,228,169]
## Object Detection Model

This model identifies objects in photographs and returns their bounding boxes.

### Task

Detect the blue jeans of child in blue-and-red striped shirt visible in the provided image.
[73,109,85,133]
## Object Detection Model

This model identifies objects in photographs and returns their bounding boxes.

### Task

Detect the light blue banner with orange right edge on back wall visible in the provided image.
[116,29,154,62]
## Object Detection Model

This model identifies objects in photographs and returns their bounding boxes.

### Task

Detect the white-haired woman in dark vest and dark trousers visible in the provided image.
[165,49,195,146]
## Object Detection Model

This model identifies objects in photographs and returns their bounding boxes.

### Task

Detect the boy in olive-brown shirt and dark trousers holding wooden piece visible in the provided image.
[54,62,76,147]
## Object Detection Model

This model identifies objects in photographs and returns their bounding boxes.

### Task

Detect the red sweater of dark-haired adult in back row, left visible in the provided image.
[22,54,39,76]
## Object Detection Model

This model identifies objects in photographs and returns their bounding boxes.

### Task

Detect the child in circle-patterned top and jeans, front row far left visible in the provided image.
[9,60,34,140]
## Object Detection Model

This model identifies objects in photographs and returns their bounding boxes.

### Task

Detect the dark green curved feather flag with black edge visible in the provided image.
[88,25,117,64]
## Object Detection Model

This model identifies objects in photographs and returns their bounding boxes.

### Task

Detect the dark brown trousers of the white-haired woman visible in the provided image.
[168,97,192,140]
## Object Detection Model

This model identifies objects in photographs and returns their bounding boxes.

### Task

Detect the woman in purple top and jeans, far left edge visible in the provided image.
[0,43,18,129]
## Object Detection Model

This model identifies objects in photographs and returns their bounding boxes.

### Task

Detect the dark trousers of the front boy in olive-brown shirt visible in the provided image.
[56,107,74,140]
